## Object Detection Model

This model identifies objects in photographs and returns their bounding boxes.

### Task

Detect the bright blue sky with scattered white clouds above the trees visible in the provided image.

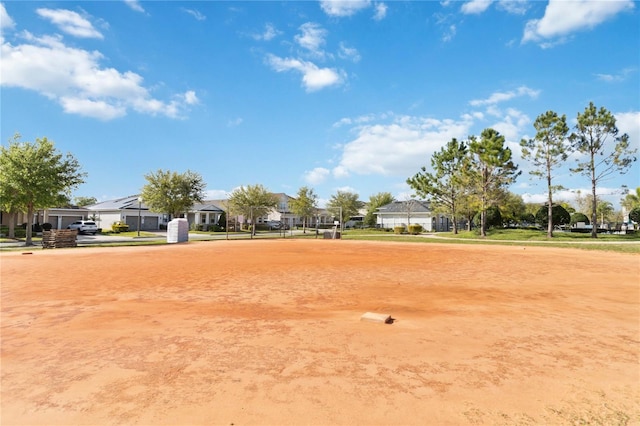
[0,0,640,210]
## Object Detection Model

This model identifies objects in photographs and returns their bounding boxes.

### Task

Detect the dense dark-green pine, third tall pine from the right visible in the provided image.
[465,129,520,237]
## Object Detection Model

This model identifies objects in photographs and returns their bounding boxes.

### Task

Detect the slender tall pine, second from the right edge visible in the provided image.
[520,111,571,238]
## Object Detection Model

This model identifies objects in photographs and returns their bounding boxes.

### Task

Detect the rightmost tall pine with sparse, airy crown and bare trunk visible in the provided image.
[569,102,637,238]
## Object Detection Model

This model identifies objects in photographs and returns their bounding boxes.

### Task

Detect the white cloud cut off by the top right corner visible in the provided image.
[522,0,634,47]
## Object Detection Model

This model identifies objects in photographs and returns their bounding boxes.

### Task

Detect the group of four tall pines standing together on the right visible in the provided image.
[407,103,636,238]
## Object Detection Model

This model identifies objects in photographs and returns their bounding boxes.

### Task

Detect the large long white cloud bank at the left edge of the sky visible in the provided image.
[0,32,197,120]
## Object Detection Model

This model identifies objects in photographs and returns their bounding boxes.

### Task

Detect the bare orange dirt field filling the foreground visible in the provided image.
[0,240,640,425]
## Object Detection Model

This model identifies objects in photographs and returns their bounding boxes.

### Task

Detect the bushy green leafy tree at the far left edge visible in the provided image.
[0,134,87,246]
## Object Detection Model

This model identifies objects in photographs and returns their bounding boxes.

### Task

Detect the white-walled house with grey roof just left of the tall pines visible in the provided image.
[375,200,451,232]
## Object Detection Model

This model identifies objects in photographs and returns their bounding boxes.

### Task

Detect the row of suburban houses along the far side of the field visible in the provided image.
[0,193,450,231]
